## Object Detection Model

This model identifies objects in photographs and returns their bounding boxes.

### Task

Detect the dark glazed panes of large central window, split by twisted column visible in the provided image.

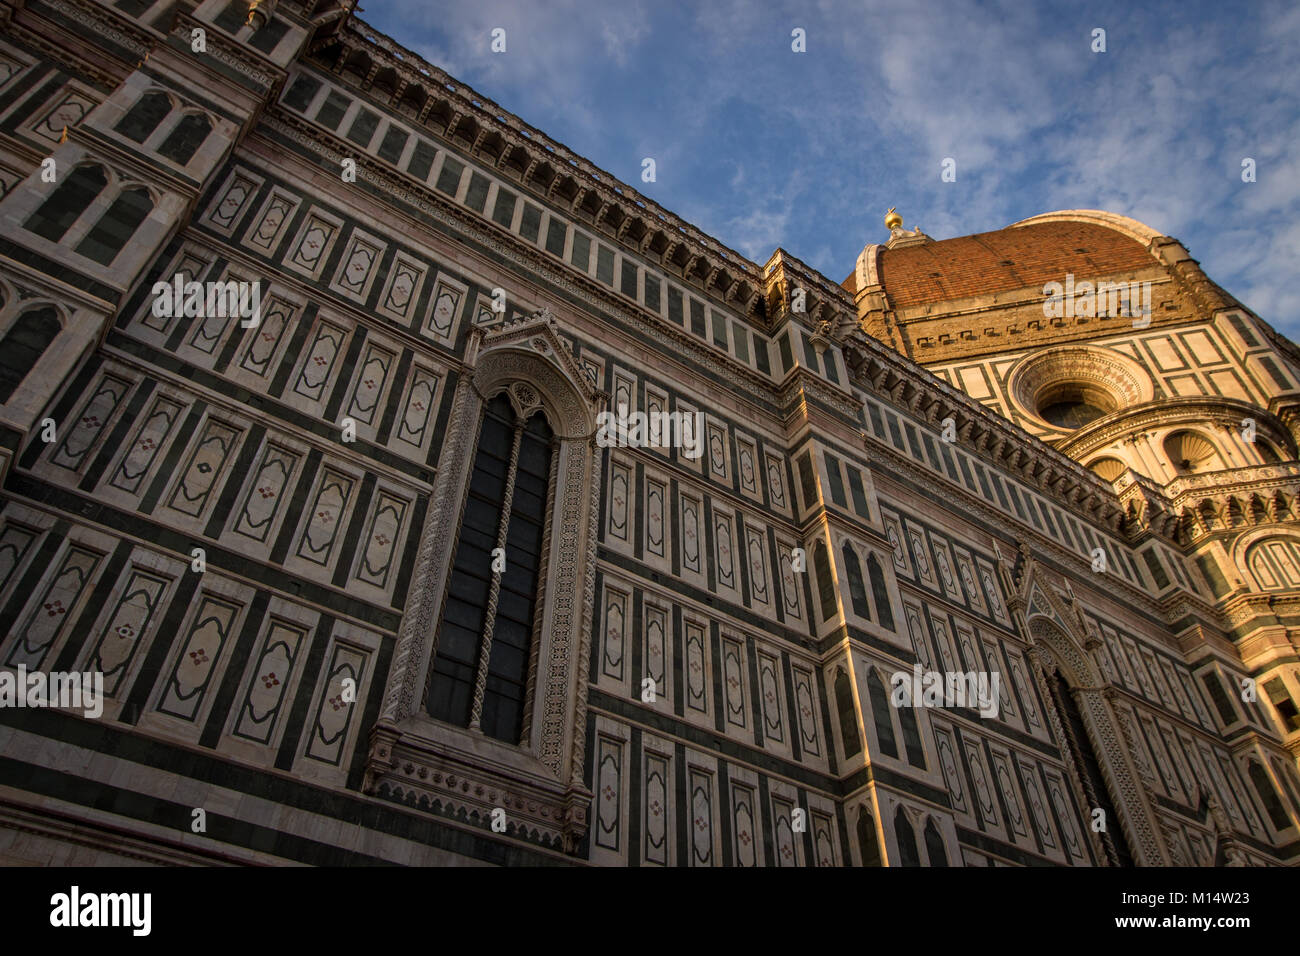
[428,394,554,743]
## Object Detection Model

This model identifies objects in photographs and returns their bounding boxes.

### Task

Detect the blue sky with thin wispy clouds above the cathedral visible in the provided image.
[360,0,1300,339]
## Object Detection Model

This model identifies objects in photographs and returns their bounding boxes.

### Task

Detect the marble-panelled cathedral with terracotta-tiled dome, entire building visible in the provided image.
[0,0,1300,866]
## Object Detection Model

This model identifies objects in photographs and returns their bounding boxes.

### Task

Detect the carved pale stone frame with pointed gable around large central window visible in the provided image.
[364,311,608,852]
